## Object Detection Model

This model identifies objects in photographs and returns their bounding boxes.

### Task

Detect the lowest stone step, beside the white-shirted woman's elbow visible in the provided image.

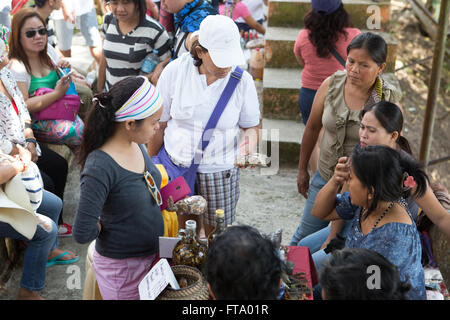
[262,118,305,166]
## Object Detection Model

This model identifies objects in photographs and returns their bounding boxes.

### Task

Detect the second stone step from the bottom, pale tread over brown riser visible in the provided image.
[262,68,401,121]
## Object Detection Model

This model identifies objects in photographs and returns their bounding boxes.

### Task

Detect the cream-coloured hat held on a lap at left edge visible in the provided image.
[0,175,37,240]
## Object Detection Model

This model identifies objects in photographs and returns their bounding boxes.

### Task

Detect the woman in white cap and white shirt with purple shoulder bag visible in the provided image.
[149,15,260,234]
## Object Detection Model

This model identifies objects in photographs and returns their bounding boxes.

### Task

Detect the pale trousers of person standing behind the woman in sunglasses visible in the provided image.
[54,9,102,51]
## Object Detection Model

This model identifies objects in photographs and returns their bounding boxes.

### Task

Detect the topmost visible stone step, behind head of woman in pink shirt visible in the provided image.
[268,0,391,31]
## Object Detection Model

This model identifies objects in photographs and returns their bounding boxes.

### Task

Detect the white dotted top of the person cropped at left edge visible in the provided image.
[0,67,31,154]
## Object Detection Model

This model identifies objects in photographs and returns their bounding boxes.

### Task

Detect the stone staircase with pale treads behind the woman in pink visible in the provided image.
[262,0,399,163]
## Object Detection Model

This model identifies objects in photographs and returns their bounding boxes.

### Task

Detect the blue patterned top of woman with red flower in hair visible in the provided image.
[336,192,426,300]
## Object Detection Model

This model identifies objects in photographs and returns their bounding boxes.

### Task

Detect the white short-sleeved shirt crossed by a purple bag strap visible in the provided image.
[157,53,260,173]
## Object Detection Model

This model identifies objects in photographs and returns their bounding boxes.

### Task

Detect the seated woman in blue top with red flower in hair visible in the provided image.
[312,146,428,299]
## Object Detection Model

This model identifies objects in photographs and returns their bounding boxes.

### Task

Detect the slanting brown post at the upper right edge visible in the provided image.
[419,0,449,166]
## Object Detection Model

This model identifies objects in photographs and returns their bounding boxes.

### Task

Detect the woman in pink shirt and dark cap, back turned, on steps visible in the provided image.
[294,0,361,124]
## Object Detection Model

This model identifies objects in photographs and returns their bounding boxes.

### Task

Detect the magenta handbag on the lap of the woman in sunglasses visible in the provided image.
[33,88,81,121]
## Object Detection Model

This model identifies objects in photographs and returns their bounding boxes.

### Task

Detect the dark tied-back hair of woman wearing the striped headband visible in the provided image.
[78,77,144,167]
